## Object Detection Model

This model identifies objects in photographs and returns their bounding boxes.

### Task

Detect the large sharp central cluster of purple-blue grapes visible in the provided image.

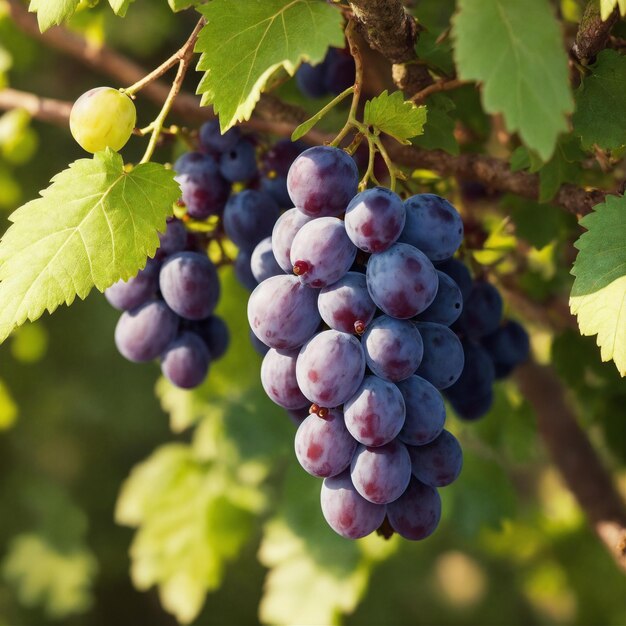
[248,147,464,540]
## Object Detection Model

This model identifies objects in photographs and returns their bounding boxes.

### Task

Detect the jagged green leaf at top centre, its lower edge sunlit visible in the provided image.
[196,0,344,132]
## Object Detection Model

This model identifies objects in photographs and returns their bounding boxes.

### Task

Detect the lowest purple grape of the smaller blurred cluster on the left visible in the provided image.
[161,332,211,389]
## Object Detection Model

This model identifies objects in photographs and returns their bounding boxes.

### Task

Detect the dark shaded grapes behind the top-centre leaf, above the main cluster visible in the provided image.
[296,48,355,98]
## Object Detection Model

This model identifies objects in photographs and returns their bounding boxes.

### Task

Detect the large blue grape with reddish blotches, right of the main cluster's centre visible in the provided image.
[367,243,439,319]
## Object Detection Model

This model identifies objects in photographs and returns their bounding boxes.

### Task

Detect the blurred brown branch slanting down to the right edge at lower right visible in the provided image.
[515,363,626,571]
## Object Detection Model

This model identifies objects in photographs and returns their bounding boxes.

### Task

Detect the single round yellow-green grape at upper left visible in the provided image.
[70,87,137,152]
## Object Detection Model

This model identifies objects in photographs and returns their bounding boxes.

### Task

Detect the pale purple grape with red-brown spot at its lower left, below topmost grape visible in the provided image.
[291,217,356,288]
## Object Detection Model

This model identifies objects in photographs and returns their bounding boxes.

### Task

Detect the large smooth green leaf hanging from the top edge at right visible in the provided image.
[453,0,573,161]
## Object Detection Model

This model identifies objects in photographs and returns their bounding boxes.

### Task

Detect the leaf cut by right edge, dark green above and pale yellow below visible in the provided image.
[570,196,626,376]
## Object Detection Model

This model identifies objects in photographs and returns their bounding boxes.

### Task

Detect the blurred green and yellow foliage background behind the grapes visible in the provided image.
[0,0,626,626]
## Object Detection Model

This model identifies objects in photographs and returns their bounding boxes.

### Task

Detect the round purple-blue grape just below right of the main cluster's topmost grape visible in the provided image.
[346,187,406,253]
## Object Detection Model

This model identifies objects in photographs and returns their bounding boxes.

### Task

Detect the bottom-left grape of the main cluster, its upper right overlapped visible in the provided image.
[320,471,386,539]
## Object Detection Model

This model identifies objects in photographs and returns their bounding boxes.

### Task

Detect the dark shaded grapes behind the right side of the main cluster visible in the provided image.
[440,266,530,420]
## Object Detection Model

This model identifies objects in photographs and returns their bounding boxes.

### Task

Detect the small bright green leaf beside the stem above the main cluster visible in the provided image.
[363,89,426,144]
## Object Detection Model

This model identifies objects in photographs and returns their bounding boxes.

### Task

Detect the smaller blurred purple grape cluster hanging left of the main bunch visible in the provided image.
[104,219,229,389]
